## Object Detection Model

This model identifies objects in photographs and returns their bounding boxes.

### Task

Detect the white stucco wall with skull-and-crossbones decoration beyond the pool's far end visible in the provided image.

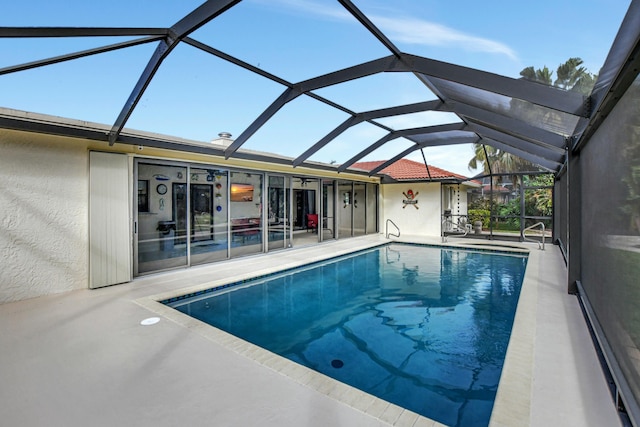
[380,183,442,236]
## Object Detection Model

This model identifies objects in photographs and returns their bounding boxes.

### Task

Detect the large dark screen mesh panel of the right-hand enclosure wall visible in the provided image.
[580,75,640,410]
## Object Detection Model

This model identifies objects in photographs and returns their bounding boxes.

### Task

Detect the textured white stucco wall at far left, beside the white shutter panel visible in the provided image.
[0,130,88,303]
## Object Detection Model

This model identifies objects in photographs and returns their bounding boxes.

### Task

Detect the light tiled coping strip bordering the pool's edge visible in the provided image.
[134,239,539,427]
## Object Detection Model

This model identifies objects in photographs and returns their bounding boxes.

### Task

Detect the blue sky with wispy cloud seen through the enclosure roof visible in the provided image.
[0,0,630,176]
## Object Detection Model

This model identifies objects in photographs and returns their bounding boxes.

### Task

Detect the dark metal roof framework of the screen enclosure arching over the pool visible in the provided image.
[0,0,638,174]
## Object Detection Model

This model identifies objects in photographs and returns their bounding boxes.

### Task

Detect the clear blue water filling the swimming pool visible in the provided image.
[169,244,527,426]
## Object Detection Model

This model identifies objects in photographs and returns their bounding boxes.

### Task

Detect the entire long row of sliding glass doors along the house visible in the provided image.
[133,159,377,275]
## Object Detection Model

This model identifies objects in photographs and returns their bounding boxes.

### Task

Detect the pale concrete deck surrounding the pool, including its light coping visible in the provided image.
[0,235,621,427]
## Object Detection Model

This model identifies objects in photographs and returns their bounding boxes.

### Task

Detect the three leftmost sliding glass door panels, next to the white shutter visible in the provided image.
[134,160,263,275]
